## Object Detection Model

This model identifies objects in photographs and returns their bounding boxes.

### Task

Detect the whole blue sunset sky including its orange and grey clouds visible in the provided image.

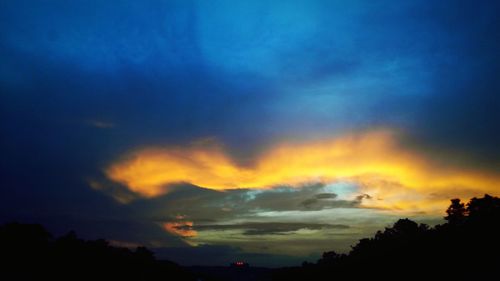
[0,0,500,267]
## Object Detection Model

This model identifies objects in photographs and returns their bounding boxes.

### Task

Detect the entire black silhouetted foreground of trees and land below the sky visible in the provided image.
[0,195,500,281]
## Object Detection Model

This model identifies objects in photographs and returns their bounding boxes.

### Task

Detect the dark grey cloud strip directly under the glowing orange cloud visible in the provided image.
[123,184,370,225]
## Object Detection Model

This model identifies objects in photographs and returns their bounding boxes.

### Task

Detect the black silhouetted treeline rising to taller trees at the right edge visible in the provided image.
[274,195,500,281]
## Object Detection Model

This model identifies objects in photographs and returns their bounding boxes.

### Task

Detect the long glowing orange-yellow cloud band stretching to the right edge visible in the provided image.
[106,130,500,212]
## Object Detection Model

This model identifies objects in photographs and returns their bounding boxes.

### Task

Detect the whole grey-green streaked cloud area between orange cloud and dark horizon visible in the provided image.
[102,184,376,259]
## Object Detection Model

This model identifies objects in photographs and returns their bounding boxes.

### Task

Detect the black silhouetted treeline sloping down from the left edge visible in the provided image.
[0,223,196,280]
